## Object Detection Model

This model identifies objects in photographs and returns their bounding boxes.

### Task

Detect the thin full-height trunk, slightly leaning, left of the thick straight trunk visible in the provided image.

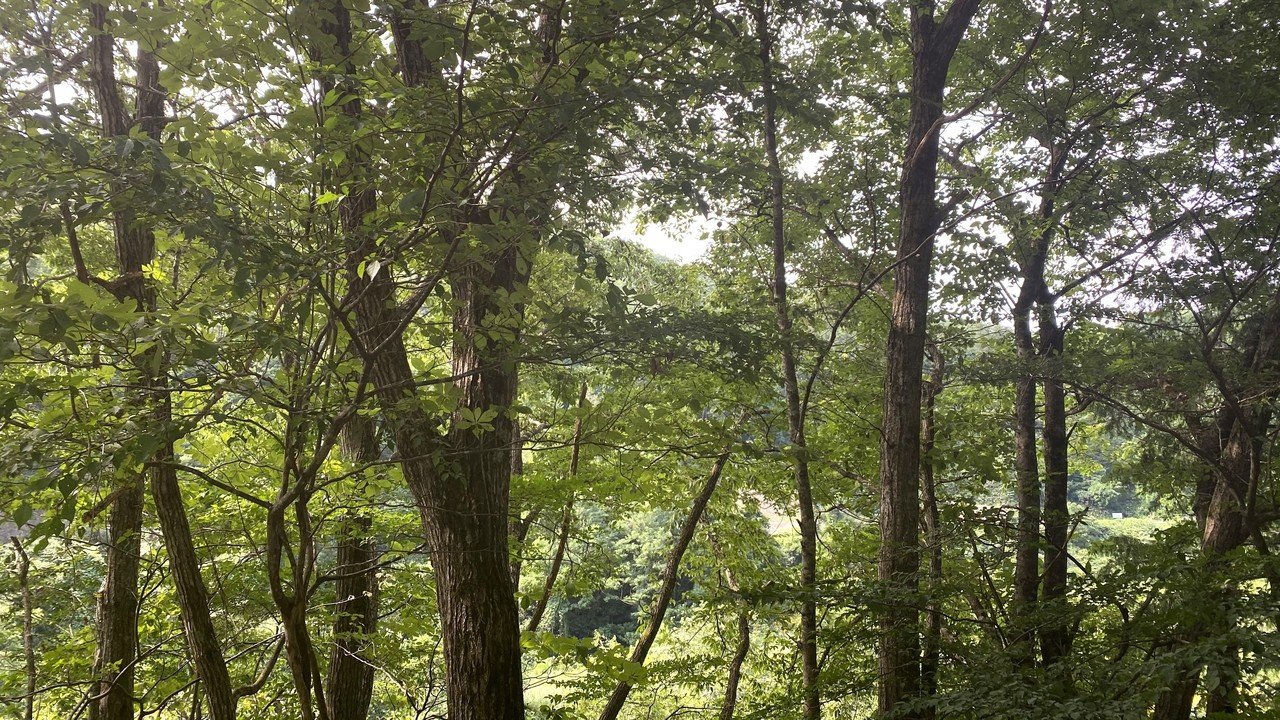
[751,1,822,720]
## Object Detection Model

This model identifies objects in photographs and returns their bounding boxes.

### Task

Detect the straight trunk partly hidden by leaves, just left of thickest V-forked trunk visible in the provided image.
[325,414,381,720]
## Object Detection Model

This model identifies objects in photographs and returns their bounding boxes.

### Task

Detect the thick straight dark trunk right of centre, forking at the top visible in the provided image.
[878,0,980,717]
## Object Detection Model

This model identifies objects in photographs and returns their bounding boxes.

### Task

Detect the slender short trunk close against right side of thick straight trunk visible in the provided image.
[920,345,945,720]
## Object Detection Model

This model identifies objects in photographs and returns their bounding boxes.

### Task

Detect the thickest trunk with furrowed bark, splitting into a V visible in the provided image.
[314,3,536,720]
